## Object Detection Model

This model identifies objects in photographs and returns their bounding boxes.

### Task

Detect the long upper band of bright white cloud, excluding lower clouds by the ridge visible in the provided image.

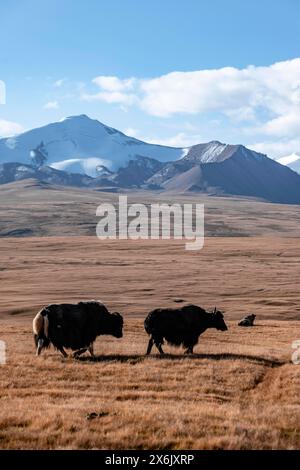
[84,58,300,120]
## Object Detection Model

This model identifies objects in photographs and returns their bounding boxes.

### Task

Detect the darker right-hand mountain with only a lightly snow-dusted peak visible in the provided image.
[147,141,300,204]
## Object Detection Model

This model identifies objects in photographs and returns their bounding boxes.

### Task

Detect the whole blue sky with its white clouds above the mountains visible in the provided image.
[0,0,300,157]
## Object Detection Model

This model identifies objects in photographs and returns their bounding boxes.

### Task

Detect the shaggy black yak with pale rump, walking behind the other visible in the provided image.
[33,300,123,357]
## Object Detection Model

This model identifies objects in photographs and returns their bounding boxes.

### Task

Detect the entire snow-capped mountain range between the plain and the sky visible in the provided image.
[0,115,300,204]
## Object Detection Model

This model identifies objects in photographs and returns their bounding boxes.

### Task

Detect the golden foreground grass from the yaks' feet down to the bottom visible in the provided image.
[0,317,300,449]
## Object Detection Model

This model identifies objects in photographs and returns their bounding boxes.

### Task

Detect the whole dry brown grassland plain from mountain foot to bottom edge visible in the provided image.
[0,183,300,449]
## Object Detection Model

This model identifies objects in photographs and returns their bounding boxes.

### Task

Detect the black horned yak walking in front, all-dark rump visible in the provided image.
[144,305,227,354]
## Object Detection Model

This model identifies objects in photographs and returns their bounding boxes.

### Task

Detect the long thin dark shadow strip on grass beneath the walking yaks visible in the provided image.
[76,353,284,367]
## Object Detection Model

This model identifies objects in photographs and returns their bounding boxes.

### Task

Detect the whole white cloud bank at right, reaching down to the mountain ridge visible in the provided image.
[82,58,300,156]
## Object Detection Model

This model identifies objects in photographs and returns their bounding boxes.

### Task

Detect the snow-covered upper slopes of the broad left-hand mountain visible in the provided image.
[0,115,184,177]
